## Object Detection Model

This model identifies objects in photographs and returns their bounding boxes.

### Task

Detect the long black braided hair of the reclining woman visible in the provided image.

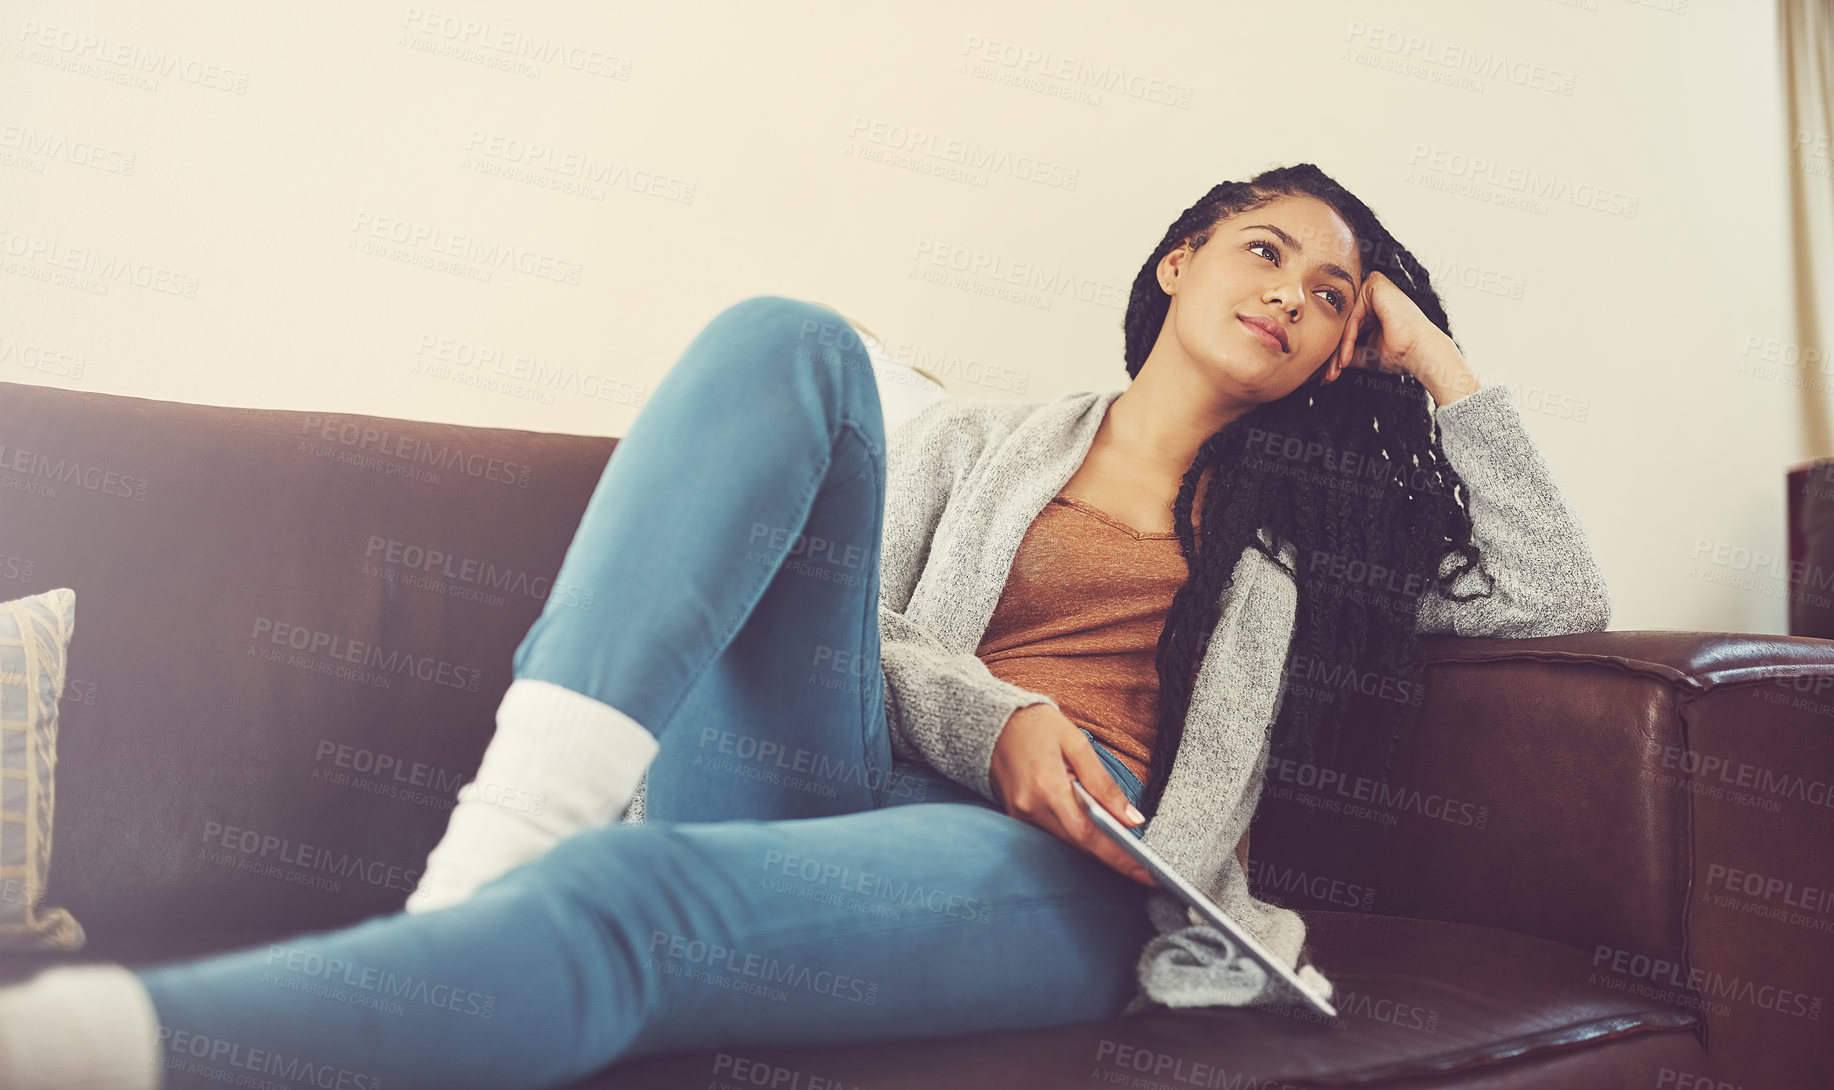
[1122,163,1489,822]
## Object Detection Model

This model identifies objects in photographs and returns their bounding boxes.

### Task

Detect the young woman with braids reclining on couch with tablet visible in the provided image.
[0,163,1608,1090]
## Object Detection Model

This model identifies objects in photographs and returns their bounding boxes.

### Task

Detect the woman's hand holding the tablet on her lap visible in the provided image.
[987,705,1159,888]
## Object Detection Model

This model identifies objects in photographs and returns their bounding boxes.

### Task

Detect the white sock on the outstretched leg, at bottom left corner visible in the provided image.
[0,965,163,1090]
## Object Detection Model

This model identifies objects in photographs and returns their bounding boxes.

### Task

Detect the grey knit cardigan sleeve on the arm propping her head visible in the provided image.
[1416,384,1610,639]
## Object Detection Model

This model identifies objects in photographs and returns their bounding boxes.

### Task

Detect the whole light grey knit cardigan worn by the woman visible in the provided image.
[627,384,1610,1015]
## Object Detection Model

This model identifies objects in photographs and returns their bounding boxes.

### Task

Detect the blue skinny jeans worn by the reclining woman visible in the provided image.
[139,295,1154,1090]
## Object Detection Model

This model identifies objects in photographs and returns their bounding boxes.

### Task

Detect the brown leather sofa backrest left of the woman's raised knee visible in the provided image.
[0,382,616,936]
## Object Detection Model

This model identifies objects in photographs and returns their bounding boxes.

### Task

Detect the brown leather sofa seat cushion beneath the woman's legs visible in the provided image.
[0,912,1706,1090]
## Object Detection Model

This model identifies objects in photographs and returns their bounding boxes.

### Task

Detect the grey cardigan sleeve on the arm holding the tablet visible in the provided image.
[878,398,1056,800]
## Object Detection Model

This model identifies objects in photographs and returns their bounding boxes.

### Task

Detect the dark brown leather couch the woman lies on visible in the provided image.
[0,382,1834,1090]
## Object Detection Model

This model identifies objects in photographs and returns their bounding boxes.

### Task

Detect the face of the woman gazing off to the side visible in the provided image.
[1159,196,1363,404]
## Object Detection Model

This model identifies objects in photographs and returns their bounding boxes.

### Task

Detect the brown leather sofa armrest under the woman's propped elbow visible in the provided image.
[1370,631,1834,1086]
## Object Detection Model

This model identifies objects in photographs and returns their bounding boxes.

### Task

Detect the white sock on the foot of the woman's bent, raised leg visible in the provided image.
[405,677,658,912]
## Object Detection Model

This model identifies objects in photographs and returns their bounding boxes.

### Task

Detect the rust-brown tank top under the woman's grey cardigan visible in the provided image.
[974,495,1188,784]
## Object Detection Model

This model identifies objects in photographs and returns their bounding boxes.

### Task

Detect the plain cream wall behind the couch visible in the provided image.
[0,0,1804,631]
